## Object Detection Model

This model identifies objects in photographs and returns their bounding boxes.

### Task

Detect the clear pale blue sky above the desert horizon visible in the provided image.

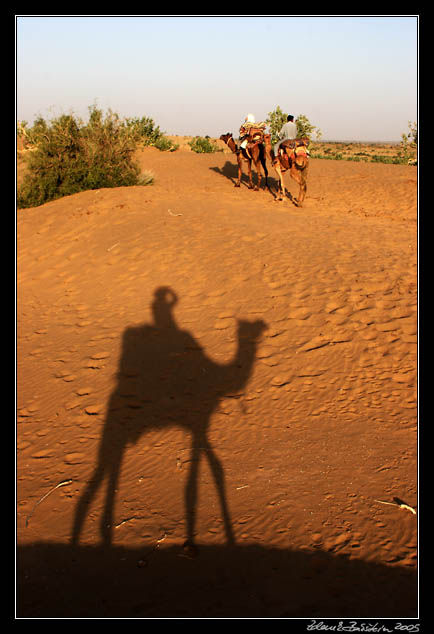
[16,15,418,141]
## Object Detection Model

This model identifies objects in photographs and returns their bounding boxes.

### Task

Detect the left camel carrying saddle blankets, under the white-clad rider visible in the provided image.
[220,121,268,191]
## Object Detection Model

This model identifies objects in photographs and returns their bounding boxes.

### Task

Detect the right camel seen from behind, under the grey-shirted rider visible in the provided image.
[264,134,309,207]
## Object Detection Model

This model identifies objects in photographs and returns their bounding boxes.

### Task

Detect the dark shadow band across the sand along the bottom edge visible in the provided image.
[17,543,417,619]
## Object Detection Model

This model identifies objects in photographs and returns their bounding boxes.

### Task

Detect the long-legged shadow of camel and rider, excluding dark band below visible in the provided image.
[72,287,267,547]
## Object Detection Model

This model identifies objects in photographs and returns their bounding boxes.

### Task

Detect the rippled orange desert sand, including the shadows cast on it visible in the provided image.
[16,148,418,619]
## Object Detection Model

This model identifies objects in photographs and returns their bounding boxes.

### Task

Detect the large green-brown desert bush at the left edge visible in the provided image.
[17,106,153,208]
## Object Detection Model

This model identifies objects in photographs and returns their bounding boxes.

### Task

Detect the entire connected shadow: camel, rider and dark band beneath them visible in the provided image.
[16,287,417,618]
